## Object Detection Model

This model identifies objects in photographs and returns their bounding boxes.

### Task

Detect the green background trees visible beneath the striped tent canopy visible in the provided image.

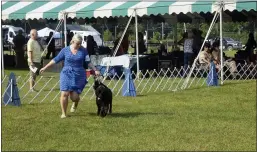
[103,22,251,44]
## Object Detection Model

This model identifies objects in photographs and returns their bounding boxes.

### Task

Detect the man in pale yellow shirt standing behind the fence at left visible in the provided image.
[27,29,43,92]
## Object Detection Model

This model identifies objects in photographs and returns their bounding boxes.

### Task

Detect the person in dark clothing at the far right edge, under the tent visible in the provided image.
[245,33,256,63]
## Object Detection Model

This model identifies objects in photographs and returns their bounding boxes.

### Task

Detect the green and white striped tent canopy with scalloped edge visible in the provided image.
[2,0,257,20]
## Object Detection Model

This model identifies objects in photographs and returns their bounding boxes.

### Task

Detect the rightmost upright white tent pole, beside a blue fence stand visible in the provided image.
[220,1,224,85]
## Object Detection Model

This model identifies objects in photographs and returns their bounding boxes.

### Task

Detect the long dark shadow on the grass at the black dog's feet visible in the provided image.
[84,112,175,118]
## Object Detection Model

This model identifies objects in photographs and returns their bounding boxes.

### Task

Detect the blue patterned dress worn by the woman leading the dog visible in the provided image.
[53,46,90,94]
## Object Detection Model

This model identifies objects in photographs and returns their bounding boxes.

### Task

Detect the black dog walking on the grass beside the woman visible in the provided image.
[94,80,112,117]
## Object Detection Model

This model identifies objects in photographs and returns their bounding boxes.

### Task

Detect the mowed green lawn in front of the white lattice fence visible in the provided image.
[2,68,256,151]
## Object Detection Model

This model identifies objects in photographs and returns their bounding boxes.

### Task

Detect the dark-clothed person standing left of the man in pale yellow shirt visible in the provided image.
[13,30,26,68]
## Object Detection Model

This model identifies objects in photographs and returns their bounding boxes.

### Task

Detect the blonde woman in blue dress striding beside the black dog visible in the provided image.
[40,34,100,118]
